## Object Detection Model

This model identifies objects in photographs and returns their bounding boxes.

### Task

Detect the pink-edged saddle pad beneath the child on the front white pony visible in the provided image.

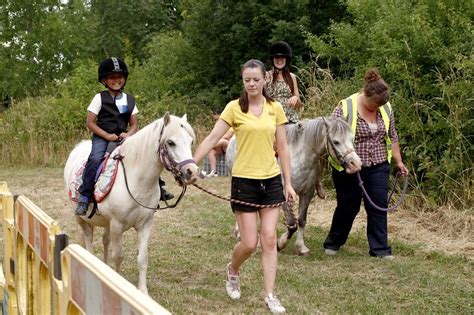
[69,142,120,203]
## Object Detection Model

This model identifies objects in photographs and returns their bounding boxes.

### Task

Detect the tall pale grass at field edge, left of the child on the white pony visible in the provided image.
[0,97,89,166]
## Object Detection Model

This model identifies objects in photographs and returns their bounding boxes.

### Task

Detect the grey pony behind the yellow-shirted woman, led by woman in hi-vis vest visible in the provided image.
[226,117,362,255]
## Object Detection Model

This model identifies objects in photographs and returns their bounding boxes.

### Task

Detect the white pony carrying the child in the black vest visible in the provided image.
[64,112,199,294]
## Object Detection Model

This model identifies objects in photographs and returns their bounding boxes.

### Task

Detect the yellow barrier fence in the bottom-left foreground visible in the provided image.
[0,182,169,314]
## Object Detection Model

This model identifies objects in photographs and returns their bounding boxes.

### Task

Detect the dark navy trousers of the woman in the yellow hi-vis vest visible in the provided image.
[323,162,392,256]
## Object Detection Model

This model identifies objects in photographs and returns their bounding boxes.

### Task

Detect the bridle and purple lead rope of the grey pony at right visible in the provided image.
[323,117,408,211]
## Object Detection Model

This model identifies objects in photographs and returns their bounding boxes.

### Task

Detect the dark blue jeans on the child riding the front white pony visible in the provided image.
[79,135,109,200]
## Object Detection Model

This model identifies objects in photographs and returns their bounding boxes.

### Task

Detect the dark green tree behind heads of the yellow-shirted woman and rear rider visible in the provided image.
[180,0,345,100]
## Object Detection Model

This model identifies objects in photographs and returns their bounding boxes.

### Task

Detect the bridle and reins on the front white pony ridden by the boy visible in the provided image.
[114,119,196,211]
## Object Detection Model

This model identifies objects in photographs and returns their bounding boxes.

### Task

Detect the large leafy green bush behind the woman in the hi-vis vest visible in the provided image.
[308,0,474,206]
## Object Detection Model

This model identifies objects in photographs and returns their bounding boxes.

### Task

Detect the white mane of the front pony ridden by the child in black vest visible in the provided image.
[122,115,196,163]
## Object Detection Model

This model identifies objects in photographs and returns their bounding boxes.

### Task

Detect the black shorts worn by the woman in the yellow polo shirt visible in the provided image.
[230,175,285,212]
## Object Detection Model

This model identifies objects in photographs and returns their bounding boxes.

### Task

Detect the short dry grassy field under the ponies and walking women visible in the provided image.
[0,168,474,314]
